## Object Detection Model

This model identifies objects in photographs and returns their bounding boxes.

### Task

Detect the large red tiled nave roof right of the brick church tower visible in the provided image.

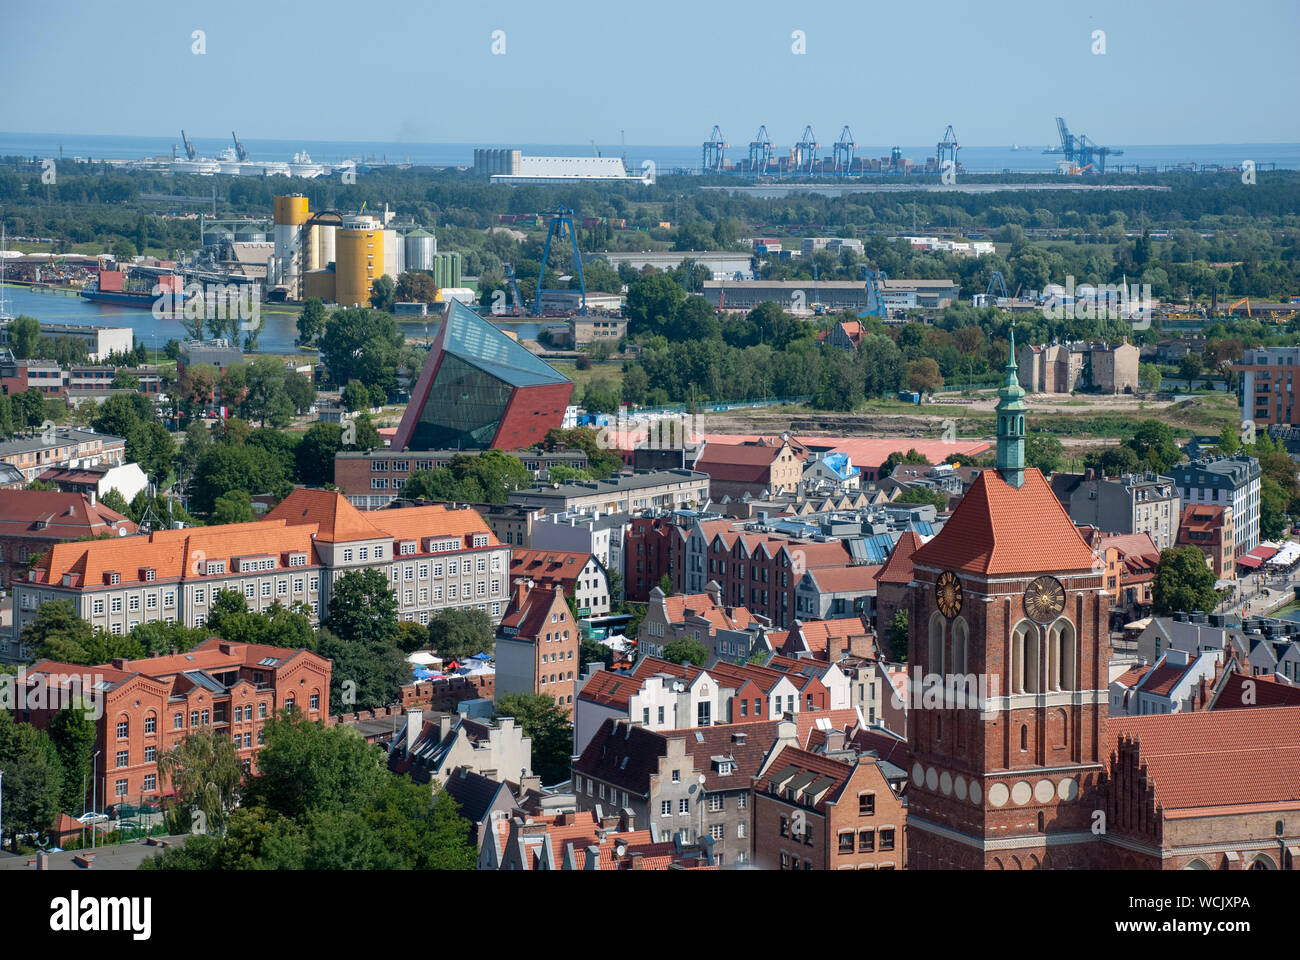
[1106,706,1300,813]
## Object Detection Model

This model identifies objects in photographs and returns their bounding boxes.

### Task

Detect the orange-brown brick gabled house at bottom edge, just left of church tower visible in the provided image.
[754,747,907,870]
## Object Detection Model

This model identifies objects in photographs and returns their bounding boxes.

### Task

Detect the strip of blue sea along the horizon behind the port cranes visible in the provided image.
[0,131,1300,174]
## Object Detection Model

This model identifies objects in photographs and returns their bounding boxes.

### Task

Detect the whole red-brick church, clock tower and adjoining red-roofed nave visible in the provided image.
[907,330,1300,869]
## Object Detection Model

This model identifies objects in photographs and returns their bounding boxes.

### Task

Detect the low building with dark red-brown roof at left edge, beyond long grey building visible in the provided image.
[0,490,137,587]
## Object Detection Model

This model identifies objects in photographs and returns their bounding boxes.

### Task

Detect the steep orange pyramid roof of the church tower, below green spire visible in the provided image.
[913,468,1096,575]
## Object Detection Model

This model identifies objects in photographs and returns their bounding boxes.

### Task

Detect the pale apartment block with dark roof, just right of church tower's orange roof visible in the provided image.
[1052,464,1185,550]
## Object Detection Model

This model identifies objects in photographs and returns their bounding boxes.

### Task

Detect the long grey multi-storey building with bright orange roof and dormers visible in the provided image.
[13,489,510,655]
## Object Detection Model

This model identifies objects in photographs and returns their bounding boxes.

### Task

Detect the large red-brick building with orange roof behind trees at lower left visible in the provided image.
[18,637,332,807]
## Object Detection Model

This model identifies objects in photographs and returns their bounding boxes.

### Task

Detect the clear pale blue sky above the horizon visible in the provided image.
[0,0,1300,146]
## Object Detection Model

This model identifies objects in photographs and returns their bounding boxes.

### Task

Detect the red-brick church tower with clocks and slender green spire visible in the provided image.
[907,323,1110,870]
